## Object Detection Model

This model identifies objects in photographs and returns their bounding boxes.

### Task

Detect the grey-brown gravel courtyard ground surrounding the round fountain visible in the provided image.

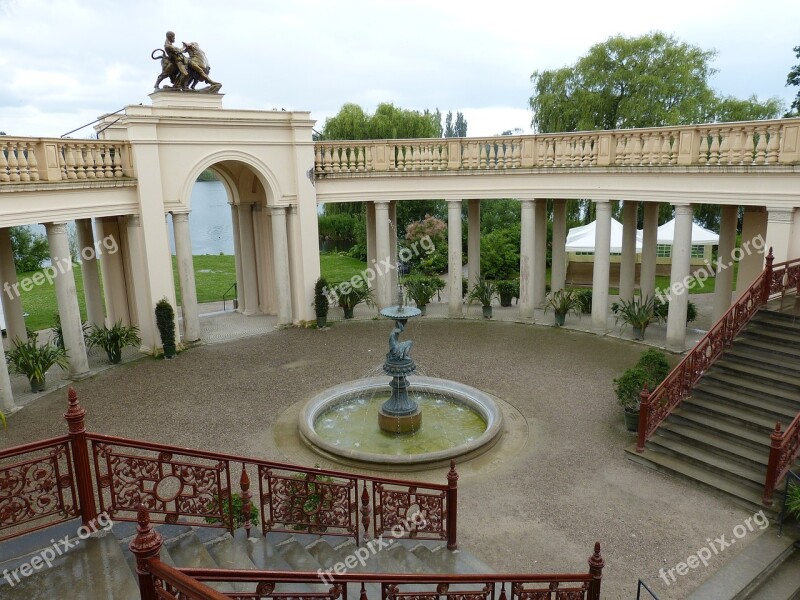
[0,296,756,599]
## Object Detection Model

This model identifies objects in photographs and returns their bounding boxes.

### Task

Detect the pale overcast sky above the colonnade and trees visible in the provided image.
[0,0,800,137]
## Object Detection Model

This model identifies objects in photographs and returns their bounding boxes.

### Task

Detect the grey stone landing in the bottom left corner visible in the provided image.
[0,530,141,600]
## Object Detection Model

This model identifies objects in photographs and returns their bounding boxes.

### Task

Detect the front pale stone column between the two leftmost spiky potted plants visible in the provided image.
[46,223,89,379]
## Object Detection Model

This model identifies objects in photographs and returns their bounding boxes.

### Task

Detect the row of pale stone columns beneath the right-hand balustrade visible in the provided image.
[366,199,800,351]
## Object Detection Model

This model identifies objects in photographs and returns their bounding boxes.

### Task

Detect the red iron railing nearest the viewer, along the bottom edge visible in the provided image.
[129,506,605,600]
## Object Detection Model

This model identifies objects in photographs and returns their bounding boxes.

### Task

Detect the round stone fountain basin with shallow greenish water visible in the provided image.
[299,376,503,470]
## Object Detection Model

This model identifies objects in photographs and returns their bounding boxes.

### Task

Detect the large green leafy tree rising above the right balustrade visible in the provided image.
[530,32,781,133]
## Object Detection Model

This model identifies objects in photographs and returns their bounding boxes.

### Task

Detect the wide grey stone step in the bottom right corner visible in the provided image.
[687,527,800,600]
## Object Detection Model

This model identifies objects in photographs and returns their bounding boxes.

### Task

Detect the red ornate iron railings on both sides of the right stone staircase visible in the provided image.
[636,248,800,506]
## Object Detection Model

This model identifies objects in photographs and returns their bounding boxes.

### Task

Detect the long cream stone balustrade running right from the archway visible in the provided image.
[314,119,800,177]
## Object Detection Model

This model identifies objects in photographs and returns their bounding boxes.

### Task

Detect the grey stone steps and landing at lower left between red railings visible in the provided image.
[0,520,494,600]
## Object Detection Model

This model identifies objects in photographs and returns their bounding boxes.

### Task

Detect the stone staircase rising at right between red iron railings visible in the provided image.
[627,310,800,512]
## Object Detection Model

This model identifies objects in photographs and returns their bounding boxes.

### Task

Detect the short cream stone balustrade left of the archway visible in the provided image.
[0,136,134,185]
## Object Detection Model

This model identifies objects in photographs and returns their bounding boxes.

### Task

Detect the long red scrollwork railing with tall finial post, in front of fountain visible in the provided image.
[0,388,458,550]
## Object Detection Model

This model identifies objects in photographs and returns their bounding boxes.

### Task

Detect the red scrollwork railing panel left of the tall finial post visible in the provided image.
[0,435,79,540]
